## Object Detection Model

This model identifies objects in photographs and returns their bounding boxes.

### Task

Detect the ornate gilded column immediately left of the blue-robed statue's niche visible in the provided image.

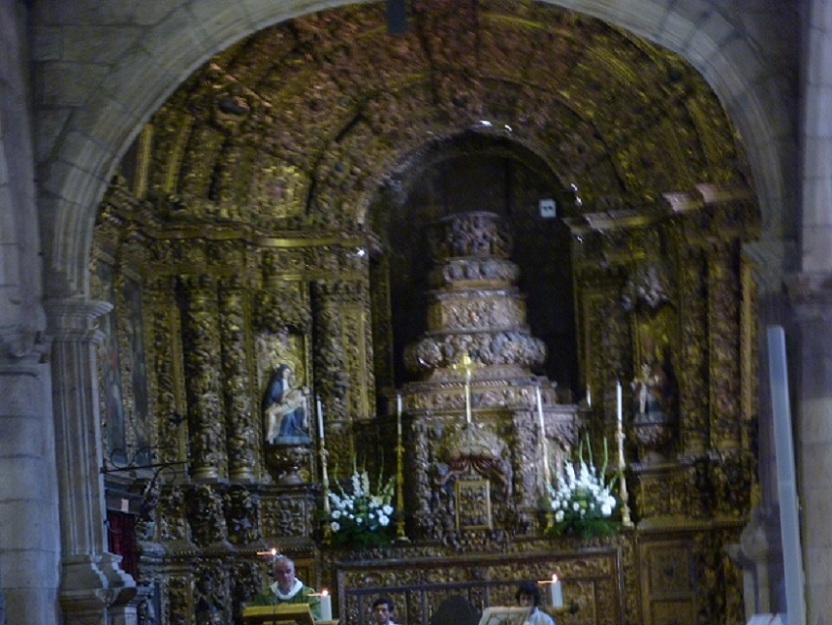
[219,276,257,482]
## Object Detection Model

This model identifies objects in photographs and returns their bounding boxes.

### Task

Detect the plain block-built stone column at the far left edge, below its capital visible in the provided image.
[0,328,56,625]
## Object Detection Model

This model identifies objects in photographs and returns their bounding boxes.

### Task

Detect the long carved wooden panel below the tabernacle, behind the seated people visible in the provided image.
[333,543,624,625]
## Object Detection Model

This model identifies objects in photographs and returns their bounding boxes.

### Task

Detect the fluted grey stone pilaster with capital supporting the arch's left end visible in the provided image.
[46,298,136,623]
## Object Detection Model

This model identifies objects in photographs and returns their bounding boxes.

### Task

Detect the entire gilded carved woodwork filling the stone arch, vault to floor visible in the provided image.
[91,2,756,625]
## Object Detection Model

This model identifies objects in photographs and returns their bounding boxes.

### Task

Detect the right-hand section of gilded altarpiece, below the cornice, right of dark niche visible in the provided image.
[569,185,756,625]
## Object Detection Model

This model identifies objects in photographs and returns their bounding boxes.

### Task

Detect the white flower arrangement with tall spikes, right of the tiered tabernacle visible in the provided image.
[547,437,618,538]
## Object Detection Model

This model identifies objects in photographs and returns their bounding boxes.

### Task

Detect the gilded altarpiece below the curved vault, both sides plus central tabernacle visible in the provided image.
[93,168,756,625]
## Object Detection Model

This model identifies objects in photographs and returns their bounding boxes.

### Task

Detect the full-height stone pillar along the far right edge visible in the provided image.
[795,0,832,623]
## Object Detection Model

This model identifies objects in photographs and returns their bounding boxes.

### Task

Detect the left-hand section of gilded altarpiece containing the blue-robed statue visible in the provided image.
[92,179,375,623]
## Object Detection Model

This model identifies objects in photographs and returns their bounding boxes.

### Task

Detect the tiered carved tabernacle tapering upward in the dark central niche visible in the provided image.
[404,212,578,541]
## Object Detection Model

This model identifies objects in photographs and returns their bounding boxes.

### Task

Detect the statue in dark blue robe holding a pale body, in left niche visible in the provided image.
[263,363,311,445]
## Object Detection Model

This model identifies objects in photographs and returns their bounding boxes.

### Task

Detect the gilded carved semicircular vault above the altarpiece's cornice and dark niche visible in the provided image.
[135,0,750,229]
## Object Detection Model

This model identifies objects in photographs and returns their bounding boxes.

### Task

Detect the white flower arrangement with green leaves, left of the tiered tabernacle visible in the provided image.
[328,467,395,547]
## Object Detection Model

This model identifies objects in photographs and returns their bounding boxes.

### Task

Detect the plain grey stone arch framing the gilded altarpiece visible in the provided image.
[37,0,795,295]
